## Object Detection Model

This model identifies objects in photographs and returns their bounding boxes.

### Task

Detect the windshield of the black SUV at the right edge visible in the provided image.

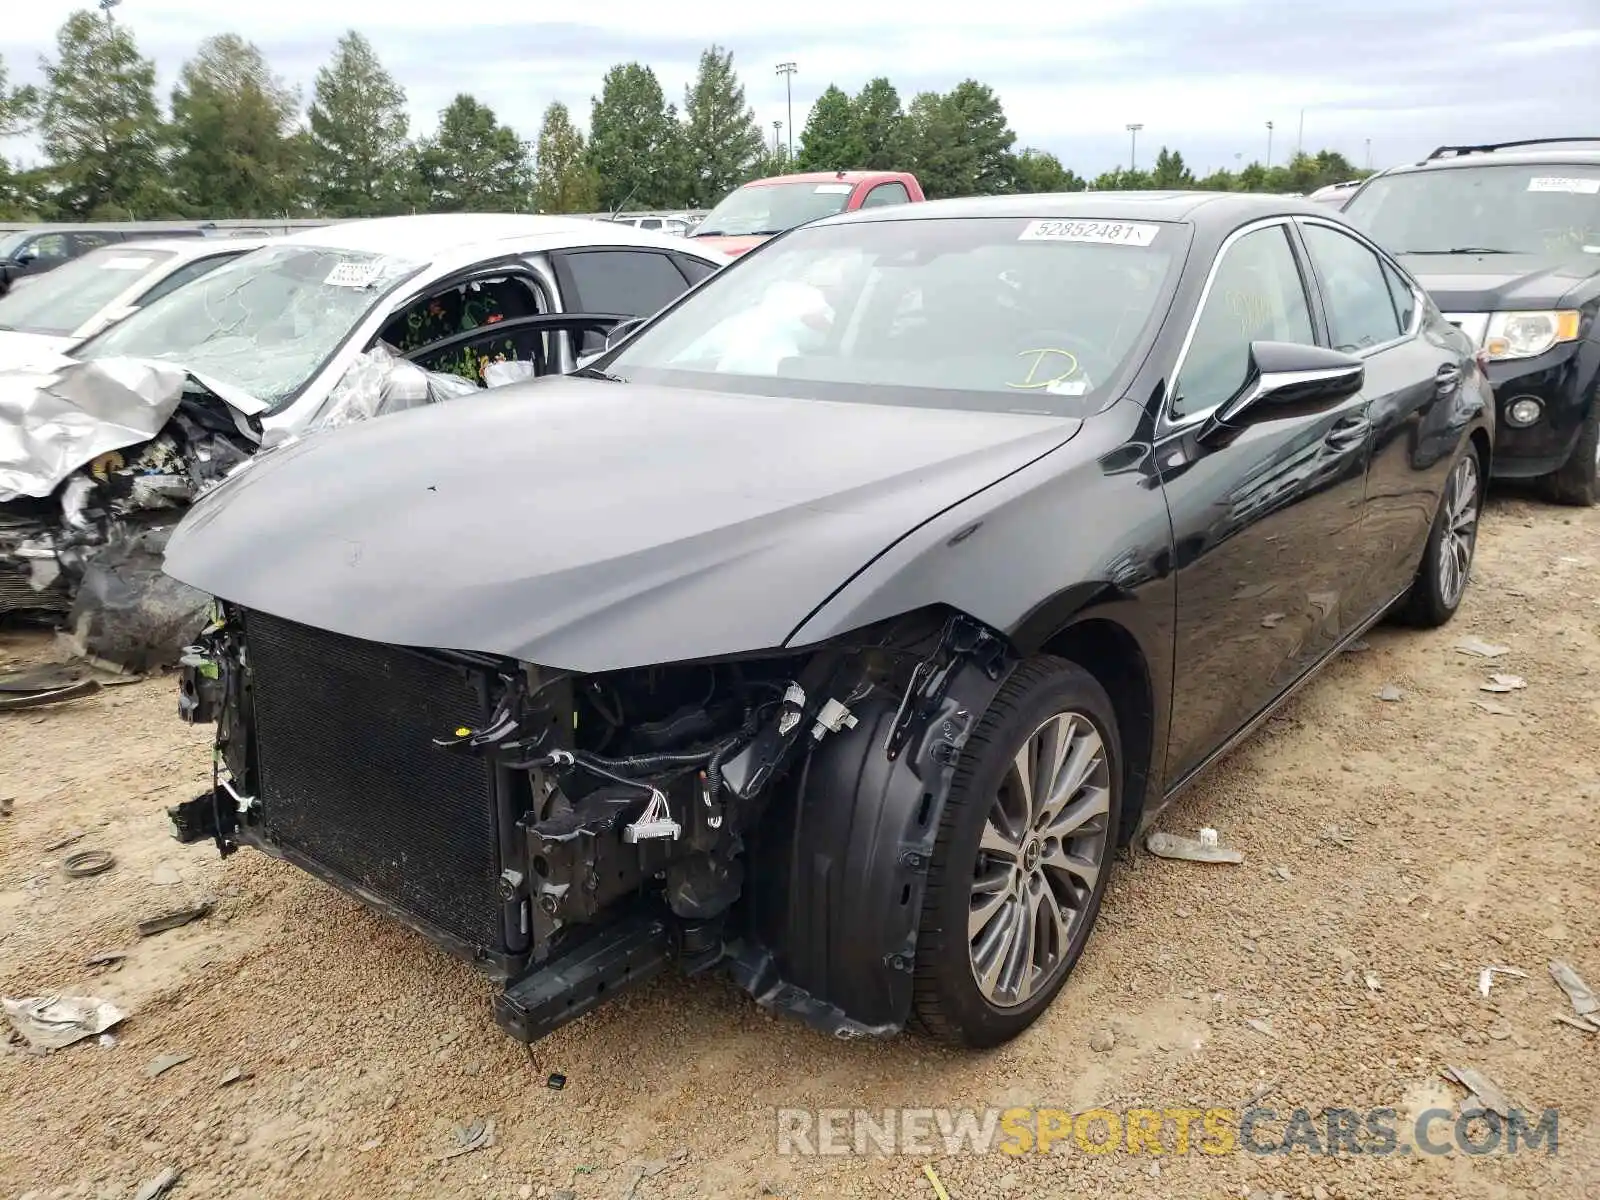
[1344,163,1600,258]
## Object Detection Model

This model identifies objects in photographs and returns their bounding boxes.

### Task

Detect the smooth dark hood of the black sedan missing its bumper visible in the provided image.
[166,378,1082,672]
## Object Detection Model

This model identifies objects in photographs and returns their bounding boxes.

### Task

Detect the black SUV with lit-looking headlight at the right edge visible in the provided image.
[1342,138,1600,504]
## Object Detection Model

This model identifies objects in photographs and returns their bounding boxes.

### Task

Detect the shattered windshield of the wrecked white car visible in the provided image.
[72,245,421,411]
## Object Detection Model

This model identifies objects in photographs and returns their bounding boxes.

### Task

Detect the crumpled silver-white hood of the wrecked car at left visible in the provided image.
[0,354,266,502]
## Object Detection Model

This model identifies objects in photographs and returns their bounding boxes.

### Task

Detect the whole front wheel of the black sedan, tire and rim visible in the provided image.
[914,658,1122,1048]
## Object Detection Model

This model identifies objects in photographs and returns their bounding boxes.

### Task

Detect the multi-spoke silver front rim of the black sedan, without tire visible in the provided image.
[966,712,1110,1008]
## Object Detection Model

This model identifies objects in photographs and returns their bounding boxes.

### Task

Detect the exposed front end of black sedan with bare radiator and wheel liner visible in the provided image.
[170,605,1011,1042]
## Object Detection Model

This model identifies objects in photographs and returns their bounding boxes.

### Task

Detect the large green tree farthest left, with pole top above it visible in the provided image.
[38,10,171,221]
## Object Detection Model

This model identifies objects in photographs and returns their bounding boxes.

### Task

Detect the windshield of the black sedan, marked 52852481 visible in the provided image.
[597,218,1187,414]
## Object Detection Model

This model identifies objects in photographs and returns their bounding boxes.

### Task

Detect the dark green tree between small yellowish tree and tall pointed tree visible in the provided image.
[589,62,685,210]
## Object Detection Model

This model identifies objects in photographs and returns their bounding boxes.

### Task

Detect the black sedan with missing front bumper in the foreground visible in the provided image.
[166,194,1493,1046]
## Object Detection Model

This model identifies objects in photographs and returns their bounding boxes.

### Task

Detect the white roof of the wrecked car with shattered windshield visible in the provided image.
[272,213,710,259]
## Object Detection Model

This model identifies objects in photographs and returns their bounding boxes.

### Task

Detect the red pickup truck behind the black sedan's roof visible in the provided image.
[693,171,926,254]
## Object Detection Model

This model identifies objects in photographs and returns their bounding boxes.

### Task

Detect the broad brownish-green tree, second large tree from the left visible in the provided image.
[170,34,304,218]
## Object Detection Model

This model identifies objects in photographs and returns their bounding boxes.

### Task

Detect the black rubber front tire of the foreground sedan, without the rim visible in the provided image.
[912,658,1122,1048]
